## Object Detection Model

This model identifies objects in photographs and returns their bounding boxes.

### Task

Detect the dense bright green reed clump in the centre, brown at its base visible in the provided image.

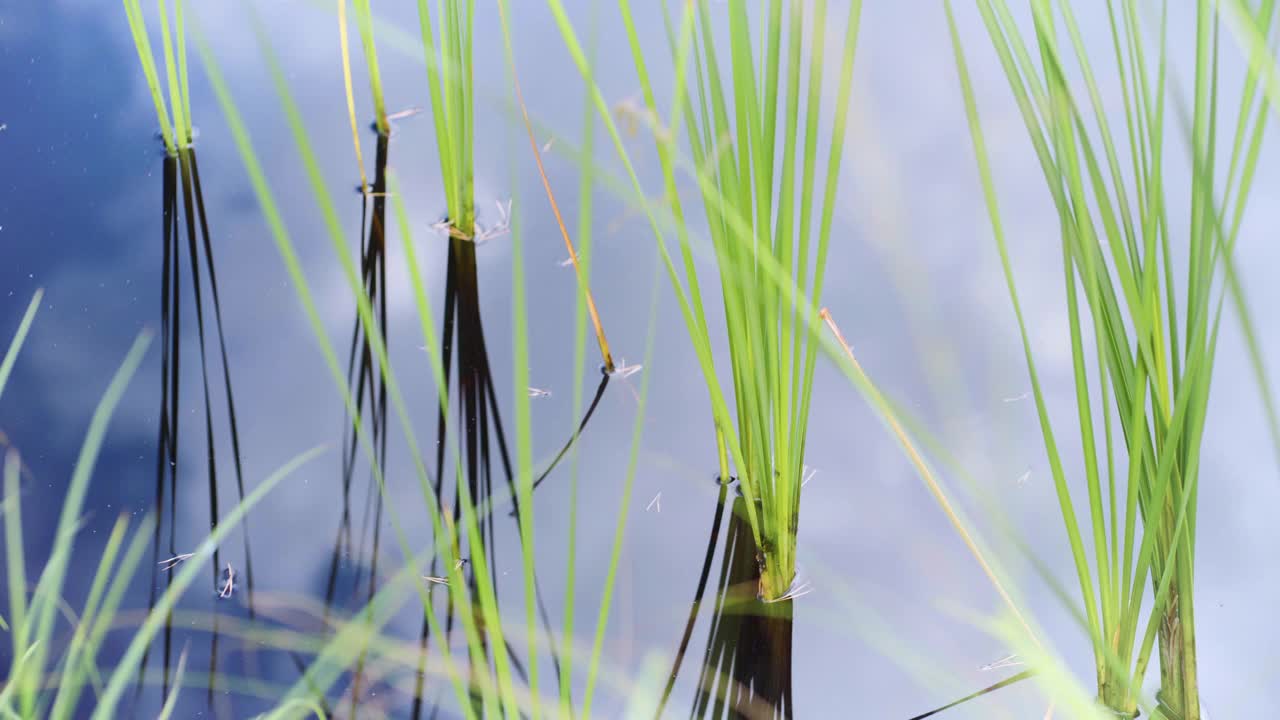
[549,0,861,600]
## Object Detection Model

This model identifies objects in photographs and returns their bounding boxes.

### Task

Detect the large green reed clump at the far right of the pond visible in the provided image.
[947,0,1275,720]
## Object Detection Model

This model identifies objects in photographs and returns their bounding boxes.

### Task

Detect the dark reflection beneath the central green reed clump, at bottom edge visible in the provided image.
[655,484,794,719]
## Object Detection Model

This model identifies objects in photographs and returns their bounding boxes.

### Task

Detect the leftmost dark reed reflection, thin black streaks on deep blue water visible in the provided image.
[138,147,253,701]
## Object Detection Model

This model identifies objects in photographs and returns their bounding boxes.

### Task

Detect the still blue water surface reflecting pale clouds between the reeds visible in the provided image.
[0,0,1280,719]
